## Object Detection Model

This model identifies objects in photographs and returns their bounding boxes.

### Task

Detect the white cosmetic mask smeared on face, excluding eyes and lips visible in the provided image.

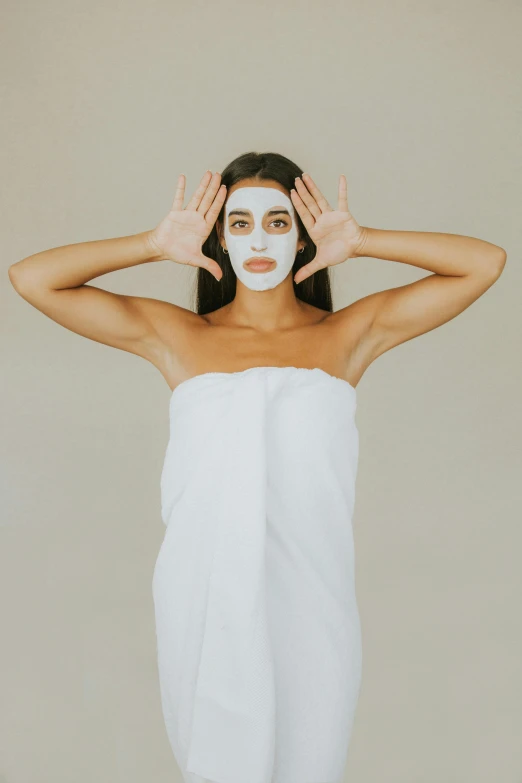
[224,187,298,291]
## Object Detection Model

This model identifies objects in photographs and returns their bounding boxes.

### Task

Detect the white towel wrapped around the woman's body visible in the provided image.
[152,367,362,783]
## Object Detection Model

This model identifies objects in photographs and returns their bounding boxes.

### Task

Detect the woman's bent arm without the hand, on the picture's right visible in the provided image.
[346,228,506,358]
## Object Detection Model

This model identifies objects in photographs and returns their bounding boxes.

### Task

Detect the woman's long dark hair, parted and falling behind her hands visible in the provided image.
[195,152,333,315]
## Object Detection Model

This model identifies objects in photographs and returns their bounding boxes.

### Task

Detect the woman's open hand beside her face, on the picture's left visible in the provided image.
[148,171,227,280]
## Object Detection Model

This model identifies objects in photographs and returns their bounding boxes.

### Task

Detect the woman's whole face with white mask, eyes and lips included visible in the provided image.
[221,179,305,291]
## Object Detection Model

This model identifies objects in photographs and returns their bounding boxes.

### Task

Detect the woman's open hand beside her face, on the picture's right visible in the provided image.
[290,174,366,283]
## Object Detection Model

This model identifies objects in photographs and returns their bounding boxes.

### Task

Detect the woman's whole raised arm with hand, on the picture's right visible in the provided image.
[291,174,506,374]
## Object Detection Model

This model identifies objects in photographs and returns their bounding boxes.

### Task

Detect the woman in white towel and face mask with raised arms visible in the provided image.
[9,153,506,783]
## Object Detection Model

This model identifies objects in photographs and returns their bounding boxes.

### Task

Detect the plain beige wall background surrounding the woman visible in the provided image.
[0,0,522,783]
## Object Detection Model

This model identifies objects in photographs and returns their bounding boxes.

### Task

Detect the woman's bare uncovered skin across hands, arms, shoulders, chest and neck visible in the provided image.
[9,171,506,389]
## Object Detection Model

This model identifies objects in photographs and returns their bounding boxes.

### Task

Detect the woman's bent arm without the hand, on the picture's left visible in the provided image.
[9,231,188,359]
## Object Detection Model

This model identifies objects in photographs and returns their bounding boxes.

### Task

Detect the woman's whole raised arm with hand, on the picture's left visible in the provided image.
[9,172,225,363]
